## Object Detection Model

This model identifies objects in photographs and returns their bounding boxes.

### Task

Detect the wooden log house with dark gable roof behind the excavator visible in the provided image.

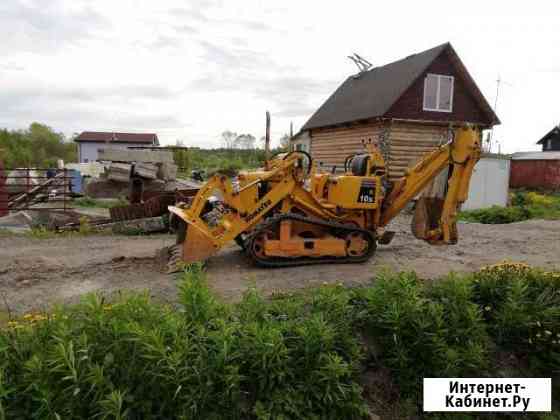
[292,43,500,180]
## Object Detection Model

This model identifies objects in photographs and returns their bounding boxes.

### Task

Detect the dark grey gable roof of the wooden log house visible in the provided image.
[302,43,499,130]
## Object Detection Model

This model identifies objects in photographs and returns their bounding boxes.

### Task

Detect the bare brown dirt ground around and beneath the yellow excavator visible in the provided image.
[0,217,560,313]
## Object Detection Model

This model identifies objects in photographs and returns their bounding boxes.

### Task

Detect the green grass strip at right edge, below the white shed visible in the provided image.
[459,191,560,224]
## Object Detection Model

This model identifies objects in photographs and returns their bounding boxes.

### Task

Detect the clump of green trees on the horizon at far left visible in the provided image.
[0,122,77,168]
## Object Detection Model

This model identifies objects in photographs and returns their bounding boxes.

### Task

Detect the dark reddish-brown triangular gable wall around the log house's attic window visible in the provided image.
[385,50,493,126]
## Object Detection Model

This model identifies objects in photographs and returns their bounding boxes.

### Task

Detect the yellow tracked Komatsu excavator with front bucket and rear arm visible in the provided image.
[164,126,481,272]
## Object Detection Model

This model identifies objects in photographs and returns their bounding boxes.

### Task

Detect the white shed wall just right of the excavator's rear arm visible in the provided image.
[462,157,510,210]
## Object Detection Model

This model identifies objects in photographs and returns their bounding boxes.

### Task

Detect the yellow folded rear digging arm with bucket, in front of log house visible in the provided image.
[379,127,480,244]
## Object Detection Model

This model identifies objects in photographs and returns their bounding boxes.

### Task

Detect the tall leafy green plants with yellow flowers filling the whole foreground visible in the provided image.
[0,263,560,419]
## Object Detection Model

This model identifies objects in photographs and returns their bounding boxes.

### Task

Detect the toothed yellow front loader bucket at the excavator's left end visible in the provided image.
[166,207,217,273]
